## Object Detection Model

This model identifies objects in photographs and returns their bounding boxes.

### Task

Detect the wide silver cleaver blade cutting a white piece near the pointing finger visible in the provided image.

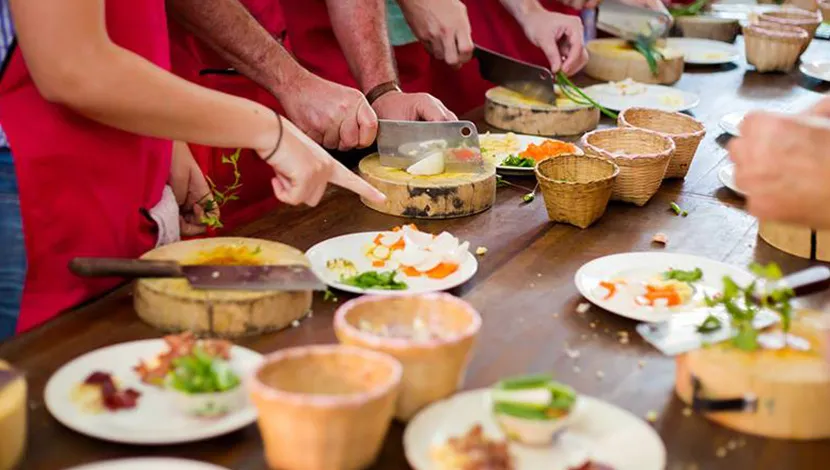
[377,119,484,173]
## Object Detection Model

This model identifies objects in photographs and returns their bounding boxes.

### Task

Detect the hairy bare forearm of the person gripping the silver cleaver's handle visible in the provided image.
[167,0,309,97]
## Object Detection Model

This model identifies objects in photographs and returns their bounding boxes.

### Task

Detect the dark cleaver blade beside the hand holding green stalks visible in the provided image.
[473,45,556,104]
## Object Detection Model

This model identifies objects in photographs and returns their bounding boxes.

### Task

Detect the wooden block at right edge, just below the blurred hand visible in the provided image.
[758,221,830,262]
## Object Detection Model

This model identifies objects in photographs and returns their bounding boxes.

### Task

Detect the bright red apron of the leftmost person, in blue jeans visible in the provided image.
[0,0,172,331]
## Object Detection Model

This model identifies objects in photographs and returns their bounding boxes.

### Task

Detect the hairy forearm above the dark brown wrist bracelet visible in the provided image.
[326,0,397,93]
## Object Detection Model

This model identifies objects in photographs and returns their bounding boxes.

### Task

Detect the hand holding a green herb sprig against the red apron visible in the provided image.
[168,141,219,236]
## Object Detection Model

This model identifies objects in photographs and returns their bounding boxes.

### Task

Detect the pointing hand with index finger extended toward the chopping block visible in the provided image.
[257,117,386,207]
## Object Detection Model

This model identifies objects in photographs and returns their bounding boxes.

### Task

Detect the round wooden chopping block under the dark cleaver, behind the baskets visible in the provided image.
[484,87,599,136]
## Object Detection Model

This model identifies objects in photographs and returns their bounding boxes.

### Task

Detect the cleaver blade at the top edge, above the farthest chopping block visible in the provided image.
[597,0,672,41]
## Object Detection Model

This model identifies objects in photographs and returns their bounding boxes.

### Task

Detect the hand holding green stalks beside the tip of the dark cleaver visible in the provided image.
[522,10,588,75]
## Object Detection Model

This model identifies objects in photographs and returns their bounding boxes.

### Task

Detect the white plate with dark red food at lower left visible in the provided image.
[43,336,263,445]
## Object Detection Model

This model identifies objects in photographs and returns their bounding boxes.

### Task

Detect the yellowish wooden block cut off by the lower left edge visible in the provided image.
[0,359,28,470]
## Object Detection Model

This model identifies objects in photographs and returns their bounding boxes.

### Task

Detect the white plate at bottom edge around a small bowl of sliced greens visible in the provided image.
[403,389,666,470]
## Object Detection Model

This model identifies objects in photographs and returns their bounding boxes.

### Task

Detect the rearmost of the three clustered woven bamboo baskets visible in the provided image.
[617,108,706,178]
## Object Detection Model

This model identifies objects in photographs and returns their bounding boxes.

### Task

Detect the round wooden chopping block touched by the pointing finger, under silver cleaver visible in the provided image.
[359,154,496,219]
